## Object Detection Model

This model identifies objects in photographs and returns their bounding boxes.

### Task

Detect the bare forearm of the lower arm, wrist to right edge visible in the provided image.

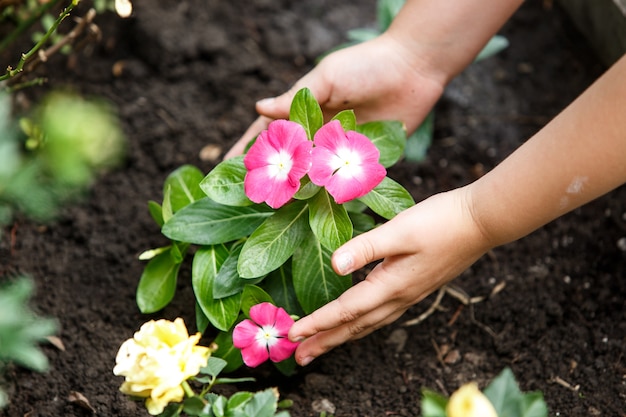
[468,56,626,246]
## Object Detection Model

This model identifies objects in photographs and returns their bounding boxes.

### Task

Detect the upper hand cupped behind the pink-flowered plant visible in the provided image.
[225,35,444,159]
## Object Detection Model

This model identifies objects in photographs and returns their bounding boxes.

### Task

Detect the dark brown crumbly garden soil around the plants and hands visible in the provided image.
[0,0,626,417]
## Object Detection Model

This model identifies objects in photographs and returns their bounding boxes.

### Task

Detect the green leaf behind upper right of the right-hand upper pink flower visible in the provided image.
[356,121,406,168]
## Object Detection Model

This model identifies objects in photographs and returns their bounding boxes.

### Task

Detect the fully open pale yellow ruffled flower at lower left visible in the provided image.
[113,318,211,415]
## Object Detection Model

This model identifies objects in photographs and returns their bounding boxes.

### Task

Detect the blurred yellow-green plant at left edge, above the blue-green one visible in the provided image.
[0,93,126,237]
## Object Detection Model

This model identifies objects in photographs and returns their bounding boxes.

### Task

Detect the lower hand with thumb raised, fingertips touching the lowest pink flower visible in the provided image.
[289,187,491,365]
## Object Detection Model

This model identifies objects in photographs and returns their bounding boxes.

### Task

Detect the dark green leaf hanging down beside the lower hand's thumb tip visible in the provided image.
[293,235,352,314]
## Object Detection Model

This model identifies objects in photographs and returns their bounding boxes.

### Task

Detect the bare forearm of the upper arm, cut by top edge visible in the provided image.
[385,0,523,85]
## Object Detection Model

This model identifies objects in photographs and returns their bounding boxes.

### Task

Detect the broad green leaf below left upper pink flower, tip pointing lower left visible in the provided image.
[237,201,309,278]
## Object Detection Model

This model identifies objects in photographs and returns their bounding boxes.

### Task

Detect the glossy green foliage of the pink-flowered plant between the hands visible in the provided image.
[136,89,415,373]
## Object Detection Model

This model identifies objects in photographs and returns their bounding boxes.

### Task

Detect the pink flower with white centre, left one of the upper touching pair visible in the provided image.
[243,120,313,208]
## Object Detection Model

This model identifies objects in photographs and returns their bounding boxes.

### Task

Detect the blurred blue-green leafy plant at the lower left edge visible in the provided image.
[0,277,57,408]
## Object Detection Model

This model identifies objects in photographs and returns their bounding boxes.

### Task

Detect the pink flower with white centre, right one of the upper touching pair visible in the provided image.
[309,120,387,204]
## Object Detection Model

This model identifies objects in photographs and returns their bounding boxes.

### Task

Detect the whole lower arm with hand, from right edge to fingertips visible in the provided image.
[289,56,626,365]
